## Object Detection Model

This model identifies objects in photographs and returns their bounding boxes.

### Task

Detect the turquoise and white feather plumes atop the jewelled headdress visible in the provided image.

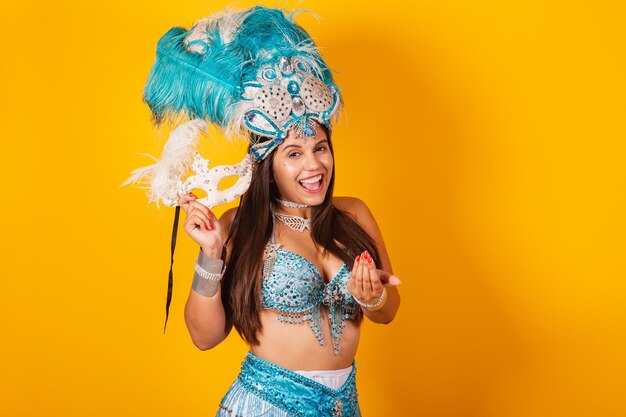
[144,6,339,136]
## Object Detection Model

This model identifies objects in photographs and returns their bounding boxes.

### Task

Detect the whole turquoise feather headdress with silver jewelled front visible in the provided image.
[144,6,341,153]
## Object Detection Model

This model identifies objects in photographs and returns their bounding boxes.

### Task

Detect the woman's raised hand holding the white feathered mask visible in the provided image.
[178,193,223,259]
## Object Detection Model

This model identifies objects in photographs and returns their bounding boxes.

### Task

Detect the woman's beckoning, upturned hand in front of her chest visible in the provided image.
[347,251,400,303]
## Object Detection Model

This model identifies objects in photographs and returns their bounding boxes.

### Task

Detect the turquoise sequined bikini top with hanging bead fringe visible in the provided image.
[261,219,357,355]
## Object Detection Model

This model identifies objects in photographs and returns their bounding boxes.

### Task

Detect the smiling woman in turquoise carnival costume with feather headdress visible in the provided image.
[134,6,400,417]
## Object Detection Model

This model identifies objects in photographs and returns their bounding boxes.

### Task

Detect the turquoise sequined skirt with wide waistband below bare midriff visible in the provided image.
[216,352,361,417]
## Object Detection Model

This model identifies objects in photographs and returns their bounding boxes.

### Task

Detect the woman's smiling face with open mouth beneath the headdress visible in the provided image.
[273,126,333,206]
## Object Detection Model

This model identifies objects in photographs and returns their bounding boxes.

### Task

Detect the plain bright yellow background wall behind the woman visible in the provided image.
[0,0,626,417]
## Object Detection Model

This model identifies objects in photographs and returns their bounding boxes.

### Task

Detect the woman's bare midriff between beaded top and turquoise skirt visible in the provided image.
[250,309,360,371]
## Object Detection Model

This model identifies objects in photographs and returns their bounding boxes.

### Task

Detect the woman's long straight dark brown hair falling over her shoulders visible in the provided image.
[222,126,380,345]
